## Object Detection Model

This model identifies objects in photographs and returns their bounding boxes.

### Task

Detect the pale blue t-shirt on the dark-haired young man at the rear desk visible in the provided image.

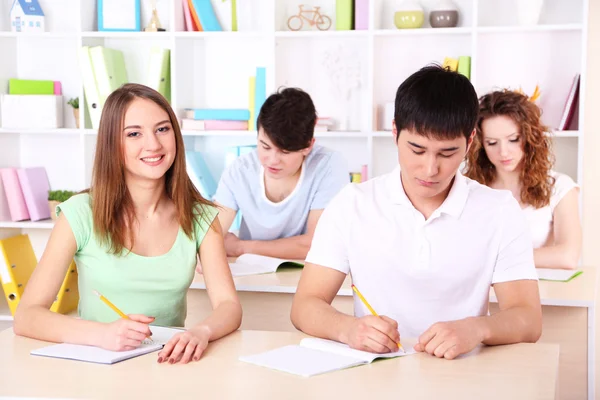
[214,145,350,240]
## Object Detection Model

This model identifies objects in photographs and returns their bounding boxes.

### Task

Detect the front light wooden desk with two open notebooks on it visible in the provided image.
[0,330,559,400]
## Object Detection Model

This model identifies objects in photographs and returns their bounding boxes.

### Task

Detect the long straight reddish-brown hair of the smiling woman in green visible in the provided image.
[85,83,214,254]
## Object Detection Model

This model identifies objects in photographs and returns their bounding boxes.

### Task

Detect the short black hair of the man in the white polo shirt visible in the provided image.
[394,65,479,140]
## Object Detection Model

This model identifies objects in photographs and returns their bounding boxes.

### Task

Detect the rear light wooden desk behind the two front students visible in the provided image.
[186,267,598,400]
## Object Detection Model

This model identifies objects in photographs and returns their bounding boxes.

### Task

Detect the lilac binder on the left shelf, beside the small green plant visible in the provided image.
[17,167,50,221]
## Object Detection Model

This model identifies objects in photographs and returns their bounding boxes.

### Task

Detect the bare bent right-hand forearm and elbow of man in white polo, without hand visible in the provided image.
[477,280,542,345]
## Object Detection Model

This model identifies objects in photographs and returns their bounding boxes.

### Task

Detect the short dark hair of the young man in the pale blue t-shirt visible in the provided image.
[256,88,317,151]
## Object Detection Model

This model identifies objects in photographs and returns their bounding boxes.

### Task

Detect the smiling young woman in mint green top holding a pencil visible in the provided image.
[14,84,242,363]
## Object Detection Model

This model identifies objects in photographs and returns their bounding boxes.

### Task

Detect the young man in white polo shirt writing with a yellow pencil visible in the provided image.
[291,66,542,359]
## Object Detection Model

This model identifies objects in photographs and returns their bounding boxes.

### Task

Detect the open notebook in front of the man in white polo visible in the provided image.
[240,338,416,377]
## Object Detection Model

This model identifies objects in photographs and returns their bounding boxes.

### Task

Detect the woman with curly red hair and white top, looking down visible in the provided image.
[465,90,582,269]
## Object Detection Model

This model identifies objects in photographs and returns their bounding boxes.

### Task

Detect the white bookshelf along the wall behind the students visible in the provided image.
[0,0,589,304]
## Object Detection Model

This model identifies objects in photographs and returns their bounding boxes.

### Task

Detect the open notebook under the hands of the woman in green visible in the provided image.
[31,326,183,364]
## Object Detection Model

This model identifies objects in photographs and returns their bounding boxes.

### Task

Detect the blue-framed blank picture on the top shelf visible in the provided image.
[98,0,142,32]
